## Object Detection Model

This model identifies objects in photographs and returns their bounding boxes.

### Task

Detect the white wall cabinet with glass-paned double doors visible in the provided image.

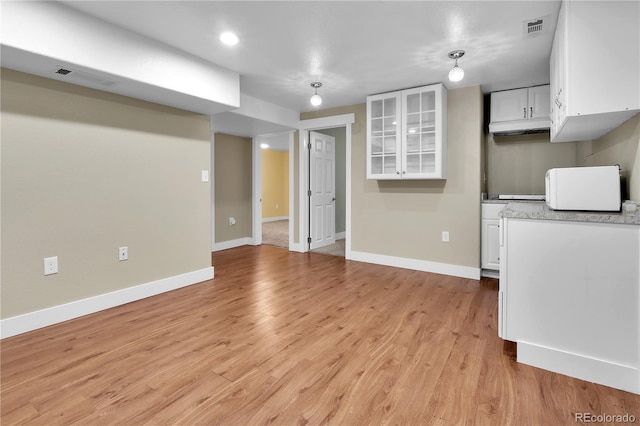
[367,84,447,180]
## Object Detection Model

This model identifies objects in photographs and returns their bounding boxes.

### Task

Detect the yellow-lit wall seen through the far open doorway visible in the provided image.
[262,149,289,219]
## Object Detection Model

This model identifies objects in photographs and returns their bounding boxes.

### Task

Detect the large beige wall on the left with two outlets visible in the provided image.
[0,69,211,318]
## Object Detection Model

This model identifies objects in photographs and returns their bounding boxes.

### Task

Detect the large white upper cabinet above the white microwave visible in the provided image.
[550,1,640,142]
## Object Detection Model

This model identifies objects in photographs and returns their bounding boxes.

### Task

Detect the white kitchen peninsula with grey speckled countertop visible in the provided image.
[498,202,640,394]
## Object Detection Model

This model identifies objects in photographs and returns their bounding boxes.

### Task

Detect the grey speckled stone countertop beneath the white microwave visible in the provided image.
[500,200,640,225]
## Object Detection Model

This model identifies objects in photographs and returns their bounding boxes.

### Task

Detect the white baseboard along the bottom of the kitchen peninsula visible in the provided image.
[517,341,640,394]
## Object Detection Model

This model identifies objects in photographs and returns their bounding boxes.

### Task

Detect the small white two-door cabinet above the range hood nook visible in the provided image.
[489,84,551,134]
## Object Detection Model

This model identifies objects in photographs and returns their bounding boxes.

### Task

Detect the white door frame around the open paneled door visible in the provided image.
[296,113,355,259]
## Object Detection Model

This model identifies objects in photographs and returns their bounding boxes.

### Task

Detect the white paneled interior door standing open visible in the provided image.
[309,132,336,250]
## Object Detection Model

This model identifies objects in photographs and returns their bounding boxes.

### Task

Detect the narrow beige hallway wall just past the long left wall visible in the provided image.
[214,133,253,243]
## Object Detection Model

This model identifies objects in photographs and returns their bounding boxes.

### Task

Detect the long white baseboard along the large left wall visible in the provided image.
[0,266,214,339]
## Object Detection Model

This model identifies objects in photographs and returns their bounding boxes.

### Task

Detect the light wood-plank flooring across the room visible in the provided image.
[0,246,640,426]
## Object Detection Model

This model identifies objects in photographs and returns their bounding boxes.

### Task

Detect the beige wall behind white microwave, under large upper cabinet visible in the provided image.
[578,114,640,202]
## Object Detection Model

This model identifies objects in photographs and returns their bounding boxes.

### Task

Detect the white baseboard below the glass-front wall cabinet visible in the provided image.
[351,251,480,280]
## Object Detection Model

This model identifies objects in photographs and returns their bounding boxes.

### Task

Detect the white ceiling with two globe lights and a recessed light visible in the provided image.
[64,0,560,112]
